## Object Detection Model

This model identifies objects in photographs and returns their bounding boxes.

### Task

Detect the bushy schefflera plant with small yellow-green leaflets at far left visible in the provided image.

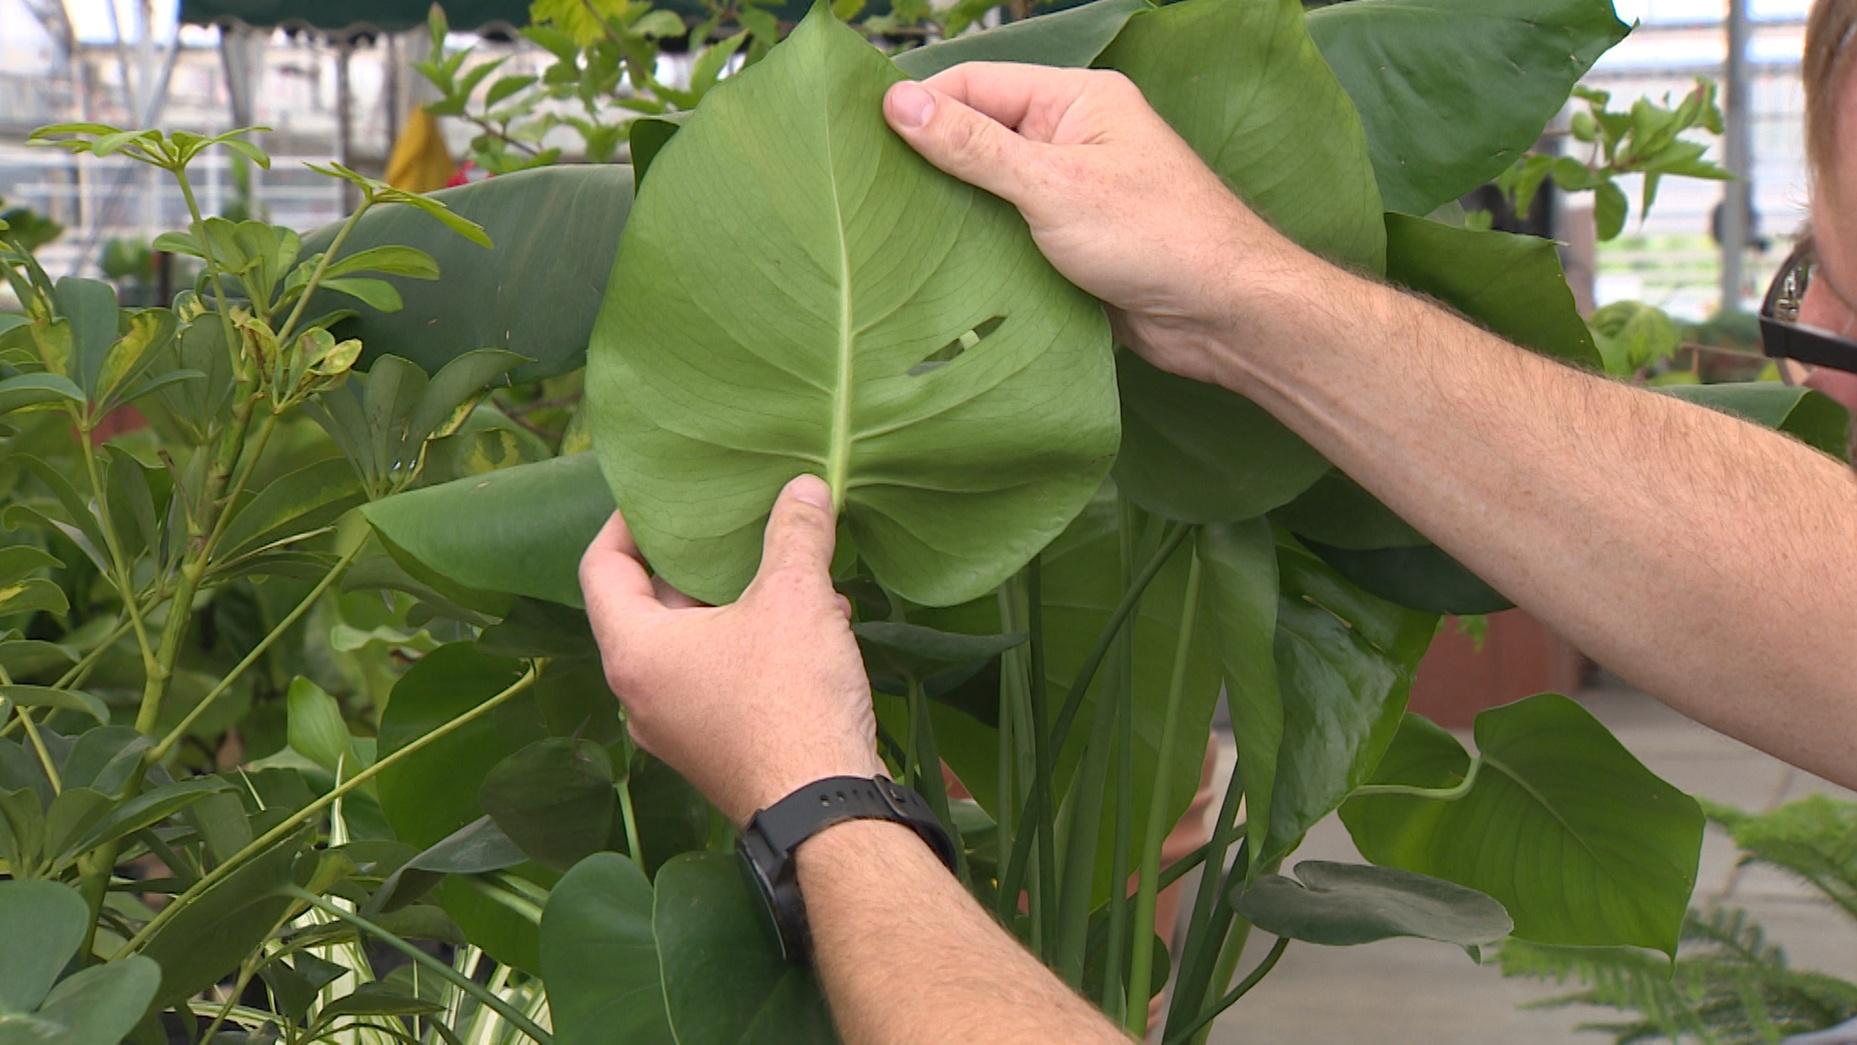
[0,123,557,1043]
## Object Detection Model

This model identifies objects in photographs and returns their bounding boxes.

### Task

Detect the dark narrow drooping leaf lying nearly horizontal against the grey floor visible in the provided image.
[1231,859,1513,958]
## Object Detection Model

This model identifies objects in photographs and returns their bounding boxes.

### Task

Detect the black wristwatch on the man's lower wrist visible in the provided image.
[735,776,954,961]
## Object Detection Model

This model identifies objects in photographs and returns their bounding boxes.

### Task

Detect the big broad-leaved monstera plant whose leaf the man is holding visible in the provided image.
[265,0,1824,1041]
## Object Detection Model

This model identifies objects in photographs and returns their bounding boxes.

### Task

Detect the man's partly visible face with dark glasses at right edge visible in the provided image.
[1799,61,1857,408]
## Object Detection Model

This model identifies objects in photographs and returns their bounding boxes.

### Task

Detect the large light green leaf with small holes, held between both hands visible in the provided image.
[587,6,1118,605]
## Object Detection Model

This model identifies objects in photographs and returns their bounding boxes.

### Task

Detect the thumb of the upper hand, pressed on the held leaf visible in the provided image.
[884,80,1032,204]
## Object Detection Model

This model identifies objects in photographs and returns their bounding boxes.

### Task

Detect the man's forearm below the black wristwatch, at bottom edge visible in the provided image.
[797,820,1123,1045]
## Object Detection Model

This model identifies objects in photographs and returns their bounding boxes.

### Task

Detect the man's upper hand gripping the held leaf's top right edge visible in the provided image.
[884,61,1307,381]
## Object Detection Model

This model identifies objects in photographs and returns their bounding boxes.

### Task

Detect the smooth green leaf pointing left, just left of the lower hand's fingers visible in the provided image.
[362,453,613,605]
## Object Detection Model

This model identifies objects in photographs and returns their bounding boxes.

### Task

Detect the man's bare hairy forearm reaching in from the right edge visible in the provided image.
[1220,258,1857,785]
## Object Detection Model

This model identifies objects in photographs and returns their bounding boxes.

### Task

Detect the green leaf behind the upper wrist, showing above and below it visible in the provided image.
[1099,0,1385,522]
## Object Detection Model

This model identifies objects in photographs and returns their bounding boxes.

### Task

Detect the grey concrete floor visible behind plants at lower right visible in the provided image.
[1211,690,1857,1045]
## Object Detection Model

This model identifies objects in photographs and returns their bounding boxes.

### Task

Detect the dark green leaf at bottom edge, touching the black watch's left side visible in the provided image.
[649,852,838,1045]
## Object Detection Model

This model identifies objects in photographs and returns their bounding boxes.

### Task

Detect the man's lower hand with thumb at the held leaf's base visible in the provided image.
[579,475,884,824]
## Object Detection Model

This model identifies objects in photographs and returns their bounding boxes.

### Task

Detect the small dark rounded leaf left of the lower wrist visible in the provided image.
[479,737,615,871]
